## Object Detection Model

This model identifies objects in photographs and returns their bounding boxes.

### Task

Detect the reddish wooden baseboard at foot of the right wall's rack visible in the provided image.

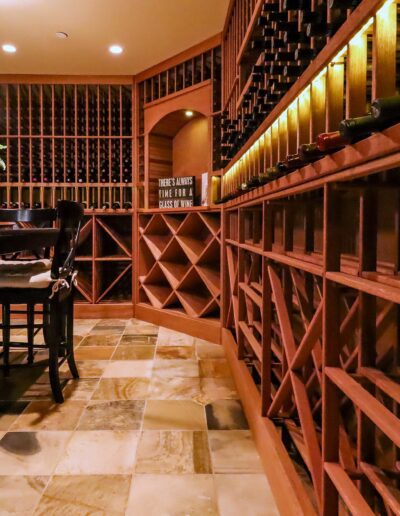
[221,329,317,516]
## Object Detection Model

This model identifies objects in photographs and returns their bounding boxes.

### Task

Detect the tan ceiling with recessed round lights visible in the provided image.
[0,0,229,75]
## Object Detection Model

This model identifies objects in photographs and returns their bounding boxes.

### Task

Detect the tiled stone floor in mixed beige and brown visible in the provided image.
[0,319,278,516]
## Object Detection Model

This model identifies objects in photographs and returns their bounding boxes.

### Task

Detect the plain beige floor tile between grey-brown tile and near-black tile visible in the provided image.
[143,400,206,430]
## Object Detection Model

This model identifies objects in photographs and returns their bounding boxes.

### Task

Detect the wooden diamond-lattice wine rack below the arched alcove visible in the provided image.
[138,210,221,326]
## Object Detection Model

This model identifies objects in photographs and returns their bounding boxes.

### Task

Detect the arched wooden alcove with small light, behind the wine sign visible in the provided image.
[147,109,211,207]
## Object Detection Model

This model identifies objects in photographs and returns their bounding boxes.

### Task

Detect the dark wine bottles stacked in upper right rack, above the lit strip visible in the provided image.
[221,0,360,166]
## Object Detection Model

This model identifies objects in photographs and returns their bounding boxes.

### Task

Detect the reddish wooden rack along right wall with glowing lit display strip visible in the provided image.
[222,0,400,515]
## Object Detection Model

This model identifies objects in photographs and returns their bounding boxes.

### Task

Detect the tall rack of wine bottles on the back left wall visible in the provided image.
[0,84,133,209]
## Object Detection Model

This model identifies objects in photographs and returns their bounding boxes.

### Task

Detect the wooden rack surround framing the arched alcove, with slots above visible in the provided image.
[136,36,221,208]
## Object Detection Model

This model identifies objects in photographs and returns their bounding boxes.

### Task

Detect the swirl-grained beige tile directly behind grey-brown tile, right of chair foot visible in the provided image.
[92,378,150,400]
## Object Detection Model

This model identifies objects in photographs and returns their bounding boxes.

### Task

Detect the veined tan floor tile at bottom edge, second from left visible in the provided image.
[35,475,131,516]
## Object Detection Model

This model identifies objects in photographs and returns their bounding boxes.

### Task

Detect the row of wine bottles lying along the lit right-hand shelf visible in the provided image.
[216,95,400,204]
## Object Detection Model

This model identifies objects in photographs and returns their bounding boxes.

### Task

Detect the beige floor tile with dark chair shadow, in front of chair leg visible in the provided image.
[11,400,86,431]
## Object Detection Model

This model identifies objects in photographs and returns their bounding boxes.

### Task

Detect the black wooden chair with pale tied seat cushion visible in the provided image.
[0,201,83,403]
